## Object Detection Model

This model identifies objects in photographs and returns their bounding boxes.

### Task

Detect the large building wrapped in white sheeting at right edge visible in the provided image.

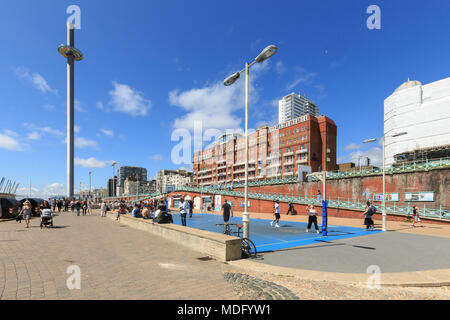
[384,77,450,166]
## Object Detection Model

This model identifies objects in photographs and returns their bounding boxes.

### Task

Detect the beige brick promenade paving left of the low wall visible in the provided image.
[0,213,241,300]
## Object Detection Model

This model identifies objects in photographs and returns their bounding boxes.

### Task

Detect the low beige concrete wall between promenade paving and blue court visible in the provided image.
[107,212,241,261]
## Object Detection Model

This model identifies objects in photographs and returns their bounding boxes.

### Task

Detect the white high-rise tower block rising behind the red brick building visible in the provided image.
[278,93,319,123]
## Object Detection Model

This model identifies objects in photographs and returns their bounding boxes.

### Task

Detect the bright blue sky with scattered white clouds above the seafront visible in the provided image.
[0,0,450,198]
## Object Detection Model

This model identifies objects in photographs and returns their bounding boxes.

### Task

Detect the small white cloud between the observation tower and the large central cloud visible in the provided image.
[109,81,152,116]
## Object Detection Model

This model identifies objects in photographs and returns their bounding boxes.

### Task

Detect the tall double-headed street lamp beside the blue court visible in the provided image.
[223,45,278,238]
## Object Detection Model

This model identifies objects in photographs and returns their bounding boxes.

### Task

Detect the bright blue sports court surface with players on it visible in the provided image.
[167,212,382,252]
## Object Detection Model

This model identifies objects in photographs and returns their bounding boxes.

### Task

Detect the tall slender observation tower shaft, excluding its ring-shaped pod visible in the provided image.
[67,23,75,198]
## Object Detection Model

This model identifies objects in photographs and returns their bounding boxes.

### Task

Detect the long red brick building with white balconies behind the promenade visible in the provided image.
[192,115,337,185]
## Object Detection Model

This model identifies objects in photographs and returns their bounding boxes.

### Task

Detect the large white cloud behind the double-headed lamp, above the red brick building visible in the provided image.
[169,61,269,131]
